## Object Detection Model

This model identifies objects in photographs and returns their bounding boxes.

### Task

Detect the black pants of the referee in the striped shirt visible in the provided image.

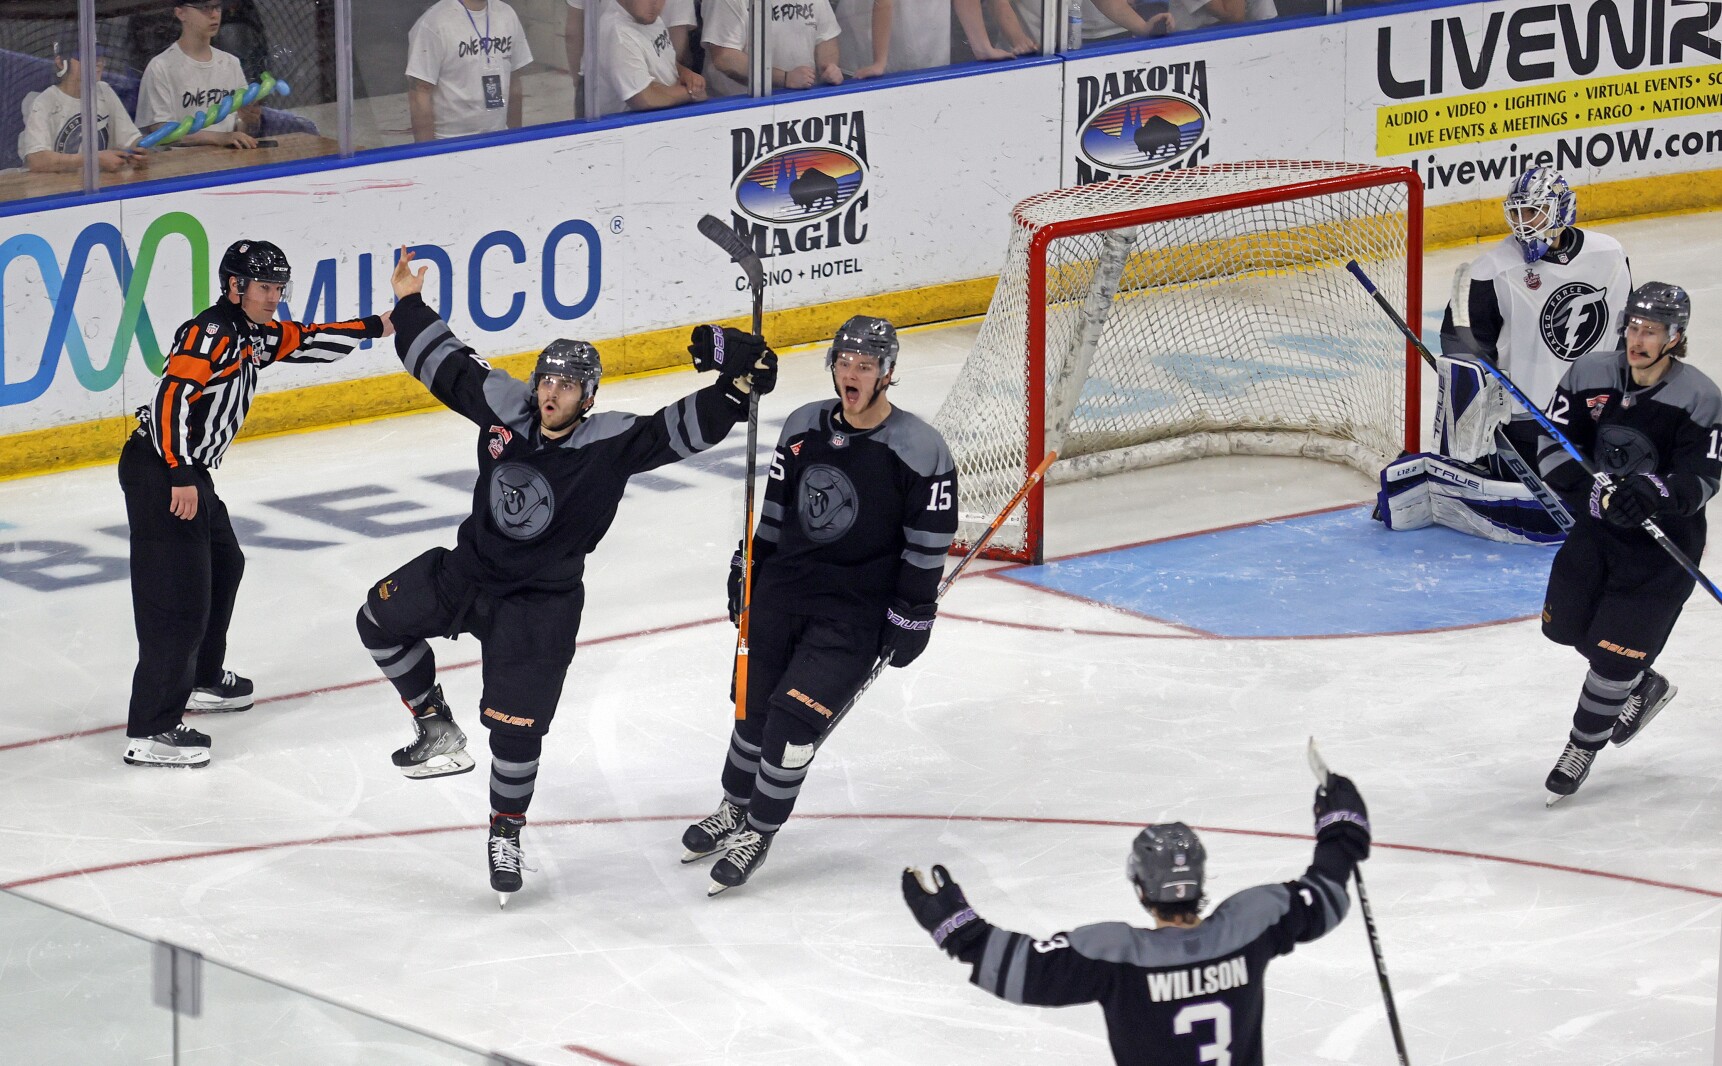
[119,434,245,737]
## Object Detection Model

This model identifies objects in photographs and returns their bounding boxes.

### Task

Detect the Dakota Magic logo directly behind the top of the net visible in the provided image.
[1076,60,1211,184]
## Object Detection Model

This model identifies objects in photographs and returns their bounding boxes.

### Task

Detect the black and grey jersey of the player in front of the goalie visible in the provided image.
[1538,351,1722,551]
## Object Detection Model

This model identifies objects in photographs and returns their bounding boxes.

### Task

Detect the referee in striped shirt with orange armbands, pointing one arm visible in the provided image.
[119,241,391,766]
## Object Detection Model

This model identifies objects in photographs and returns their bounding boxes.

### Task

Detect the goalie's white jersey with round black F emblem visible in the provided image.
[1441,227,1632,418]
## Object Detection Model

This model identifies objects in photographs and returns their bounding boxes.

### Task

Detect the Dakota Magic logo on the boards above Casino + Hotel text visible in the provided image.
[730,112,868,258]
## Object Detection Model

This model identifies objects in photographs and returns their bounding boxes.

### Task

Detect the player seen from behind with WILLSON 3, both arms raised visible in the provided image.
[902,773,1369,1066]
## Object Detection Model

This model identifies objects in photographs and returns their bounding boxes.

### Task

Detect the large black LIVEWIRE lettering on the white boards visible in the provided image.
[1376,0,1722,100]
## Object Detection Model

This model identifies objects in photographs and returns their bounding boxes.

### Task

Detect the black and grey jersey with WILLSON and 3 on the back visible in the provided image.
[957,842,1352,1066]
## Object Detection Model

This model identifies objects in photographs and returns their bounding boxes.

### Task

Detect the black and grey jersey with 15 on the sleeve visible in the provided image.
[753,398,957,625]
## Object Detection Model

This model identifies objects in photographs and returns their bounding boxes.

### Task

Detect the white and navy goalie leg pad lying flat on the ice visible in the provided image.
[1378,453,1564,544]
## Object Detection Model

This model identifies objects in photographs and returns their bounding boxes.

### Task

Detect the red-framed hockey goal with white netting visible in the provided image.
[935,160,1422,561]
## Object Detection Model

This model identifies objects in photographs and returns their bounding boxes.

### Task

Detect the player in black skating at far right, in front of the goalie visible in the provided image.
[1539,281,1722,804]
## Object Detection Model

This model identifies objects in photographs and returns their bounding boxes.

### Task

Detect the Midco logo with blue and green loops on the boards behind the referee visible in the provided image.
[0,212,603,406]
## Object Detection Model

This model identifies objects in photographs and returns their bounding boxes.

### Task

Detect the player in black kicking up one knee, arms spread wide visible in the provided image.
[358,250,777,906]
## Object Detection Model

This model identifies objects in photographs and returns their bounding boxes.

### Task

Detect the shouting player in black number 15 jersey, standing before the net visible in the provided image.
[682,315,957,896]
